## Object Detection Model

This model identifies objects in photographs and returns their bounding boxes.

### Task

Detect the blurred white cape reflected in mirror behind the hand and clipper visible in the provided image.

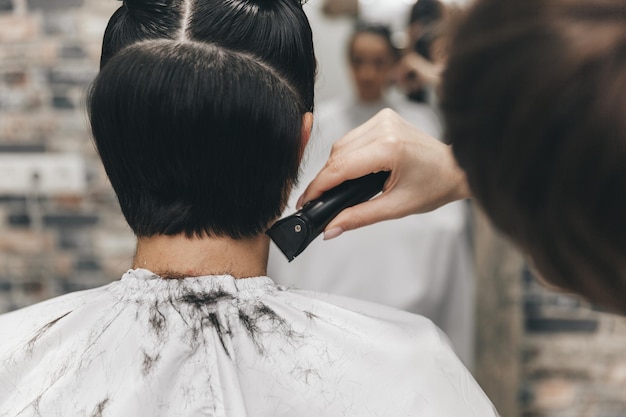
[268,96,475,368]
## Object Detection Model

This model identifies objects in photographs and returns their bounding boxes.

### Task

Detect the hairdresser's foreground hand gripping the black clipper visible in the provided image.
[298,109,469,239]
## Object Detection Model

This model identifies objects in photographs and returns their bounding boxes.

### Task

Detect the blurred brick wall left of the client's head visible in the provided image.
[0,0,134,311]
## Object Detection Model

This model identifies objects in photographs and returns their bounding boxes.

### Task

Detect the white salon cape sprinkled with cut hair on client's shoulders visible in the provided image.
[0,269,496,417]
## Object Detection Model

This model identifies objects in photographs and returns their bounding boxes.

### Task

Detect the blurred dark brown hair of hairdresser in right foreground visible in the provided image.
[442,0,626,312]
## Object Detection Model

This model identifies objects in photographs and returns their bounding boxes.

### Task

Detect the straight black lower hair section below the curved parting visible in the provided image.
[88,40,306,239]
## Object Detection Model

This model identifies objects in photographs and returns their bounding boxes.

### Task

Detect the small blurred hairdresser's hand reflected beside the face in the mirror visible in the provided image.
[392,52,444,92]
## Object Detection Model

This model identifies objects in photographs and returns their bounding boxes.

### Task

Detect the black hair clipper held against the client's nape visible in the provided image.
[266,171,389,262]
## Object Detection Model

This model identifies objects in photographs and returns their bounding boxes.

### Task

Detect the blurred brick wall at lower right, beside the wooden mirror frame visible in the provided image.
[520,270,626,417]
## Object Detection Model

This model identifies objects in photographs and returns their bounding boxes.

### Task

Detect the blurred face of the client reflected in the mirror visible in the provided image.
[348,32,396,102]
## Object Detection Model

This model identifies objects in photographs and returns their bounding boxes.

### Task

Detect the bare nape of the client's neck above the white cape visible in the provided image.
[133,235,269,278]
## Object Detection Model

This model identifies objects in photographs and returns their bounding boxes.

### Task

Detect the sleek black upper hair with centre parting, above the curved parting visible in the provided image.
[101,0,317,111]
